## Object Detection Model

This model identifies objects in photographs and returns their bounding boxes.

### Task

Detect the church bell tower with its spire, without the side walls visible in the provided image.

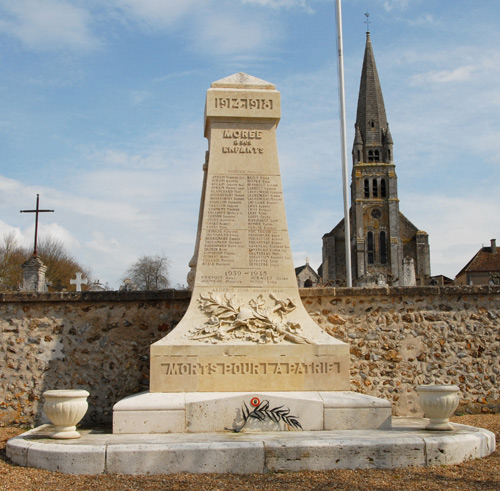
[351,32,402,281]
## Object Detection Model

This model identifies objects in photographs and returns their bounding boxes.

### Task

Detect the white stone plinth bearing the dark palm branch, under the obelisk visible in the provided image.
[113,391,392,434]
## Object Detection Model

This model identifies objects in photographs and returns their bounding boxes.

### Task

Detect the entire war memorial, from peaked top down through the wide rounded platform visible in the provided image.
[7,73,495,474]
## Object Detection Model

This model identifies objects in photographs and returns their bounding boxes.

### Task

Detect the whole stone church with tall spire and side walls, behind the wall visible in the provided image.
[319,32,430,286]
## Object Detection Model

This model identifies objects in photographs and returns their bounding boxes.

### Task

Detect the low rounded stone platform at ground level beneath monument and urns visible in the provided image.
[7,418,495,475]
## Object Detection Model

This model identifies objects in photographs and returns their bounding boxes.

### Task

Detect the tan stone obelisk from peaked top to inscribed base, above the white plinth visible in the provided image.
[150,73,349,393]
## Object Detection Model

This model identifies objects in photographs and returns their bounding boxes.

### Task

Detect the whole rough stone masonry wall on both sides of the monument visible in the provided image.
[0,287,500,424]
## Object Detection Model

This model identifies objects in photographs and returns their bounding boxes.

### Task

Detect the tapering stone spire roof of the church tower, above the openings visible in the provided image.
[356,32,392,146]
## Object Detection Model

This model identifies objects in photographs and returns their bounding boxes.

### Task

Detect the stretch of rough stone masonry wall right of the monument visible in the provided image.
[302,286,500,415]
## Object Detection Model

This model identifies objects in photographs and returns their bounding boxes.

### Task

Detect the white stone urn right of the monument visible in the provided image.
[417,385,460,431]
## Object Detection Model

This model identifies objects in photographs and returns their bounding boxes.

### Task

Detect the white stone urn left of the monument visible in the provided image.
[43,390,90,438]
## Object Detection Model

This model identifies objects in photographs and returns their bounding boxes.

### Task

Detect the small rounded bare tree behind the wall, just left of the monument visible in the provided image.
[125,254,169,290]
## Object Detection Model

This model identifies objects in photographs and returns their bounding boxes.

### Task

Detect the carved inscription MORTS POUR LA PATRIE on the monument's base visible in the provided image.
[162,361,340,376]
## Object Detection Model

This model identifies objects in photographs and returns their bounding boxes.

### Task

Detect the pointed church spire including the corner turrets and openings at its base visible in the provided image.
[353,32,392,163]
